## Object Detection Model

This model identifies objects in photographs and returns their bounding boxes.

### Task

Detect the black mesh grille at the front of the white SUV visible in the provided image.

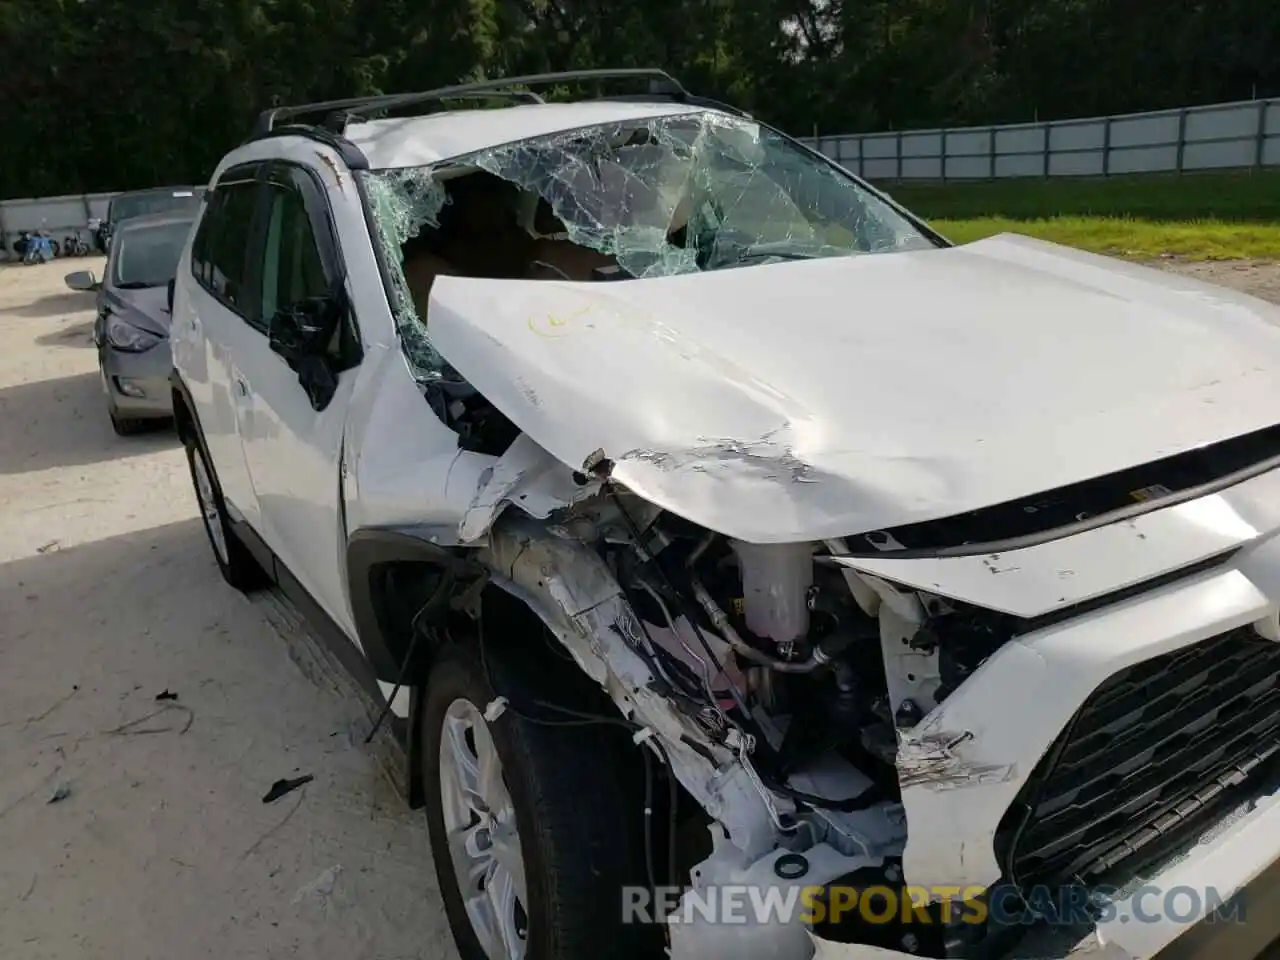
[997,627,1280,887]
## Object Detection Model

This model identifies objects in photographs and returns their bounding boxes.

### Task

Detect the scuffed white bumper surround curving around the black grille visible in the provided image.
[900,555,1280,887]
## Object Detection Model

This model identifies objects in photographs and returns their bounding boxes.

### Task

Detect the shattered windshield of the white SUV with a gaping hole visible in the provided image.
[364,111,937,370]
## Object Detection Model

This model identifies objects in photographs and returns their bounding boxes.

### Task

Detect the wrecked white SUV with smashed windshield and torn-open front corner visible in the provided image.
[172,70,1280,960]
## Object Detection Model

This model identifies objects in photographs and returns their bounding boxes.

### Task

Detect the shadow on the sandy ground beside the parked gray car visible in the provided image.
[0,371,177,475]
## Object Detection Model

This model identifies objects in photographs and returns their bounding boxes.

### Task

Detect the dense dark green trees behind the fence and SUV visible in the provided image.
[0,0,1280,197]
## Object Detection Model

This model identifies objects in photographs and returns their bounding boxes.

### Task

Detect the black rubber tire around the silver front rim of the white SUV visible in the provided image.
[421,640,663,960]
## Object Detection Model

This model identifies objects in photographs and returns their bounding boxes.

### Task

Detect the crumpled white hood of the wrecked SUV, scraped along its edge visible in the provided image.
[429,236,1280,543]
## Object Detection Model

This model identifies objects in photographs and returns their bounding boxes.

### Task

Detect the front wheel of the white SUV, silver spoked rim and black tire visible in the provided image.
[421,646,663,960]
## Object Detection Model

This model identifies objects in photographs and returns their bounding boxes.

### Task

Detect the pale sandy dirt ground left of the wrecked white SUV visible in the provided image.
[0,259,454,960]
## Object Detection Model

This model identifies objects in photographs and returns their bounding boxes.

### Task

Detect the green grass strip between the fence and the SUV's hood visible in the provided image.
[883,170,1280,260]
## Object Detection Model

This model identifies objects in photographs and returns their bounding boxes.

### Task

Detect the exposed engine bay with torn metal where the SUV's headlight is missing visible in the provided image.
[490,485,1024,956]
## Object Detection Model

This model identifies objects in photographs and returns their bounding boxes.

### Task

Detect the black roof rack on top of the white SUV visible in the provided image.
[251,68,690,140]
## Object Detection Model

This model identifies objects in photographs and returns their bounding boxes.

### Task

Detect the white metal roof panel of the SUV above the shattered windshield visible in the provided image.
[344,100,708,170]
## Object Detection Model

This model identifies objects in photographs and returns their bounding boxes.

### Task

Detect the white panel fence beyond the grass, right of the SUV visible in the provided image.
[806,99,1280,180]
